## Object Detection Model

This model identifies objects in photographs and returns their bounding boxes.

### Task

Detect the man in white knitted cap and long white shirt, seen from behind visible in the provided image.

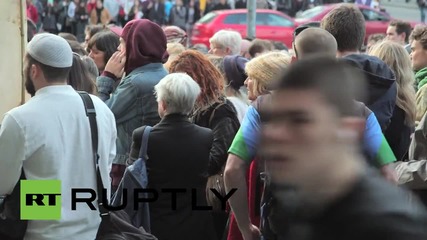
[0,33,116,240]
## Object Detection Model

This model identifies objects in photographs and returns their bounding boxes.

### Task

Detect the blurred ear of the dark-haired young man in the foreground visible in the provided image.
[337,117,365,142]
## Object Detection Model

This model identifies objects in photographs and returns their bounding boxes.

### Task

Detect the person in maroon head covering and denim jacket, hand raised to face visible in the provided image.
[97,19,168,194]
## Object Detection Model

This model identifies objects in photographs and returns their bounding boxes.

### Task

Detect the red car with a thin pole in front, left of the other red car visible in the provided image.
[191,9,297,48]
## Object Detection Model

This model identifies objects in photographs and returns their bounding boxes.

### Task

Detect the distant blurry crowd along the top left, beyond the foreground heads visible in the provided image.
[26,0,268,41]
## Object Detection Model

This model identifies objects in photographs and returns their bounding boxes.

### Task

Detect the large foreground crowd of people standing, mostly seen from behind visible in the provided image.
[4,0,427,240]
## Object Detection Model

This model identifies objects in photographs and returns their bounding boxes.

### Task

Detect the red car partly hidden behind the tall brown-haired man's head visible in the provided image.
[295,3,418,42]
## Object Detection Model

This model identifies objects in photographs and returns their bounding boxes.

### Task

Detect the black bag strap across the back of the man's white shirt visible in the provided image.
[78,91,110,218]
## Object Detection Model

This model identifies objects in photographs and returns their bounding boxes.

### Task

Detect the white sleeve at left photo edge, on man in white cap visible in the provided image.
[0,114,25,195]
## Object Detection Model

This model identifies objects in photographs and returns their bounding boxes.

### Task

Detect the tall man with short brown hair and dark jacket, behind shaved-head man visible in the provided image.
[320,4,397,132]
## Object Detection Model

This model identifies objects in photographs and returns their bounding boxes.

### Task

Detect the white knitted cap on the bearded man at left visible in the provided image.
[27,33,73,68]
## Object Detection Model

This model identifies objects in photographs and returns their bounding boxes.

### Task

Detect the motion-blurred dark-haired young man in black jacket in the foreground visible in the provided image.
[260,56,427,240]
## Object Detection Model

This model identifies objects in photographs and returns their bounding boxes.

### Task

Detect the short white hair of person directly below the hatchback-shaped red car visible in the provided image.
[209,30,242,55]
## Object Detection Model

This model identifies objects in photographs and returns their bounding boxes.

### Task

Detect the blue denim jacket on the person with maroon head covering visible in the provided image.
[96,63,168,165]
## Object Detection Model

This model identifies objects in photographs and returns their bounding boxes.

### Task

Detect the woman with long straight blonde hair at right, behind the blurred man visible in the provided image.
[369,41,416,160]
